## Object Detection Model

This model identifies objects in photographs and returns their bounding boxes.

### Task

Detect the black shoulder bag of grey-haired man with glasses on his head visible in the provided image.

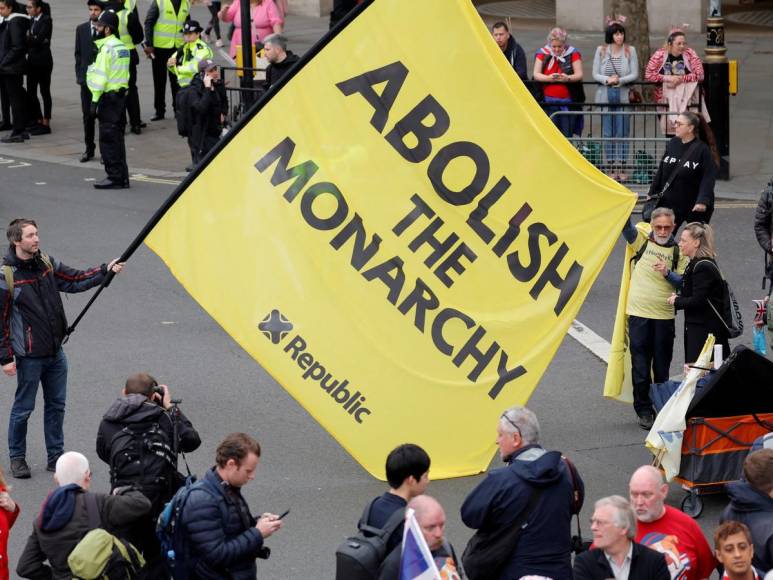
[462,487,543,580]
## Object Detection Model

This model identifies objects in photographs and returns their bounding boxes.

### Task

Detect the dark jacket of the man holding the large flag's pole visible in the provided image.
[0,251,107,364]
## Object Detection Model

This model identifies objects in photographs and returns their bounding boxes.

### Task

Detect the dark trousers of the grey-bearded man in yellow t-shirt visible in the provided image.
[628,316,676,415]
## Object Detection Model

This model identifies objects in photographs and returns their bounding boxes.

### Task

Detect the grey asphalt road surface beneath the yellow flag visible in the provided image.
[0,158,762,579]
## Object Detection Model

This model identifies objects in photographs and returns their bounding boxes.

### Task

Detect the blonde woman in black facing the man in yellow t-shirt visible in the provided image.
[668,222,730,363]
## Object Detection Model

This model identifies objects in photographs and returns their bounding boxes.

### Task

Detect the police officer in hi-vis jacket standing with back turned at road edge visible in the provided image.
[86,10,131,189]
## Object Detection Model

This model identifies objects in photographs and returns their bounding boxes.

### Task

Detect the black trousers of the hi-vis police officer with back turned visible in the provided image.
[97,91,129,183]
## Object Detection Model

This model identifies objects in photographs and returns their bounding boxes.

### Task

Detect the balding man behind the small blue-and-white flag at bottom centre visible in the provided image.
[379,495,462,580]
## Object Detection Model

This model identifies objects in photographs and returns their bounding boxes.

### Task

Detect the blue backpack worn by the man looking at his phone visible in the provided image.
[156,475,220,580]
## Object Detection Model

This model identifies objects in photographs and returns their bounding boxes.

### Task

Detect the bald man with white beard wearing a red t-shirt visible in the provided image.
[628,465,717,580]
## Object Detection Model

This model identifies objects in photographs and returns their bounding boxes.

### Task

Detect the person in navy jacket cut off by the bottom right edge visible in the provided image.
[719,449,773,571]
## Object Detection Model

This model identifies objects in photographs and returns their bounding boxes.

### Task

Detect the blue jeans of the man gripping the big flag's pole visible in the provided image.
[8,348,67,461]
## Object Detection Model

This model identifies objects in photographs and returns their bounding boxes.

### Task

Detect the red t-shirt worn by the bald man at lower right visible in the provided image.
[636,506,717,580]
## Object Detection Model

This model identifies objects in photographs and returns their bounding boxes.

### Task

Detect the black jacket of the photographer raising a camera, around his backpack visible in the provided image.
[97,394,201,513]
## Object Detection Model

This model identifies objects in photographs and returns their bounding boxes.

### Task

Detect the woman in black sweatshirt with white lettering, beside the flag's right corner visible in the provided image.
[648,113,717,228]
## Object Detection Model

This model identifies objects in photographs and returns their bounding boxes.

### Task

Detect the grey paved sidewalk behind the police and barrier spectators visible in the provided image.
[0,0,773,201]
